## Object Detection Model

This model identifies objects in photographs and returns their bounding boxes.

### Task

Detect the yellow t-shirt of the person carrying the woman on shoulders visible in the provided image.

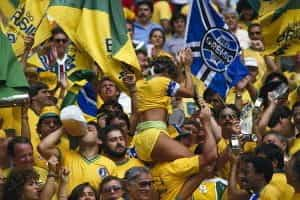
[150,156,200,200]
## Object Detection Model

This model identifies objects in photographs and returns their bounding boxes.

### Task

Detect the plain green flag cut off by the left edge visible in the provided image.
[0,28,28,100]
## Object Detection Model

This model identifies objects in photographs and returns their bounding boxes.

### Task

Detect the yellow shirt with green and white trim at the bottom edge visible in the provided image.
[193,178,228,200]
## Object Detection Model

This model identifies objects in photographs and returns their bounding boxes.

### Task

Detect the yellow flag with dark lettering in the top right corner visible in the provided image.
[261,0,300,56]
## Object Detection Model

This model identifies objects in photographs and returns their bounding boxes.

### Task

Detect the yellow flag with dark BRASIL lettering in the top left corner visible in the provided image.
[6,0,51,56]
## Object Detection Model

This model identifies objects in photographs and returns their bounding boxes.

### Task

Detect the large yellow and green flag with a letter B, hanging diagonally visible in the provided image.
[48,0,140,90]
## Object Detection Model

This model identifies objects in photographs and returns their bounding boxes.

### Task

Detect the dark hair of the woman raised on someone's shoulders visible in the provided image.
[149,56,176,76]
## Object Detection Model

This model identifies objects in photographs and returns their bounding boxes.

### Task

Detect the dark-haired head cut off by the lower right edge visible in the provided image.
[286,151,300,200]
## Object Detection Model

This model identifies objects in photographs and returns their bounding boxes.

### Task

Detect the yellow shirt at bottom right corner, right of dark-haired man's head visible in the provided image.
[259,173,294,200]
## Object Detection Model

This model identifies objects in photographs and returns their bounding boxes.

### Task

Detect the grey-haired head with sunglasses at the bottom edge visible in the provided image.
[124,167,155,200]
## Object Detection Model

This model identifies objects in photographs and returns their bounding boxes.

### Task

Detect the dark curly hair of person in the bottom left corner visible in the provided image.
[3,169,39,200]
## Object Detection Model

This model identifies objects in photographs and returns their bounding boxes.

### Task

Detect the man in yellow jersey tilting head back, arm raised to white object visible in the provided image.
[38,122,116,194]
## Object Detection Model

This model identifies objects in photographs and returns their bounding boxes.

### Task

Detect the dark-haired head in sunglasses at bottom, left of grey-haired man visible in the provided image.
[99,176,125,200]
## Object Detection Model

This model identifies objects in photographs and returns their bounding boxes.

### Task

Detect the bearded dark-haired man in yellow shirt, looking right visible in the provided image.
[101,125,144,178]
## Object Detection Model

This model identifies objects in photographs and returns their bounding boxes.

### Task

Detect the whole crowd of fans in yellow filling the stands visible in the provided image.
[0,0,300,200]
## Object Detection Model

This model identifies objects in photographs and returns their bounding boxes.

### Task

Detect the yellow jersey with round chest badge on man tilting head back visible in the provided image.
[60,149,117,194]
